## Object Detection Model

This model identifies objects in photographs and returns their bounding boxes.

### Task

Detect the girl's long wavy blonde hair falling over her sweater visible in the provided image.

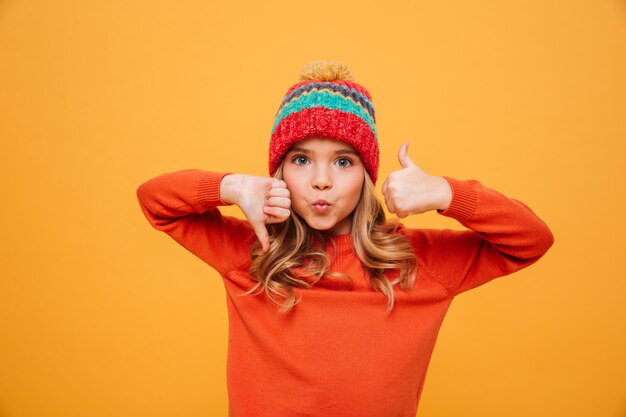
[240,161,417,313]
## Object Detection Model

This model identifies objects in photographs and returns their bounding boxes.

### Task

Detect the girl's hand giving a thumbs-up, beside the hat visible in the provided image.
[382,142,452,217]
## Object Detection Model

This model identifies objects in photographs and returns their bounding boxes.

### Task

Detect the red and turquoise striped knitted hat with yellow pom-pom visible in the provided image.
[269,61,380,184]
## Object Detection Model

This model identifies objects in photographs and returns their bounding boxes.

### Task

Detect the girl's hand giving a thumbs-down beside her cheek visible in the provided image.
[220,174,291,253]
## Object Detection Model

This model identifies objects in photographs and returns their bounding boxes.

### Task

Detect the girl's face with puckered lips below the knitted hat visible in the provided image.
[283,137,366,235]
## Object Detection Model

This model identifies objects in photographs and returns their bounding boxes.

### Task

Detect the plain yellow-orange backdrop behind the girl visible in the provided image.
[0,0,626,417]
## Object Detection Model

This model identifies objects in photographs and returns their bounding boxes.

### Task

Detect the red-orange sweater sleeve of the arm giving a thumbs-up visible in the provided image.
[418,176,554,296]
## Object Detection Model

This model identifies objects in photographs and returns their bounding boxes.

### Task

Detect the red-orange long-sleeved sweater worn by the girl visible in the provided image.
[137,169,553,417]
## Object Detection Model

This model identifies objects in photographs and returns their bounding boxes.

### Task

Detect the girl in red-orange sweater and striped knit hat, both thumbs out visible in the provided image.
[137,61,553,417]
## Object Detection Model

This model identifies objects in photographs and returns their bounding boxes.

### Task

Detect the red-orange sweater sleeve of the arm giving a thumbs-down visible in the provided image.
[137,169,256,275]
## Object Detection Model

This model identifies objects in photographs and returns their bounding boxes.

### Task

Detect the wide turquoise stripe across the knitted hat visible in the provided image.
[272,90,378,136]
